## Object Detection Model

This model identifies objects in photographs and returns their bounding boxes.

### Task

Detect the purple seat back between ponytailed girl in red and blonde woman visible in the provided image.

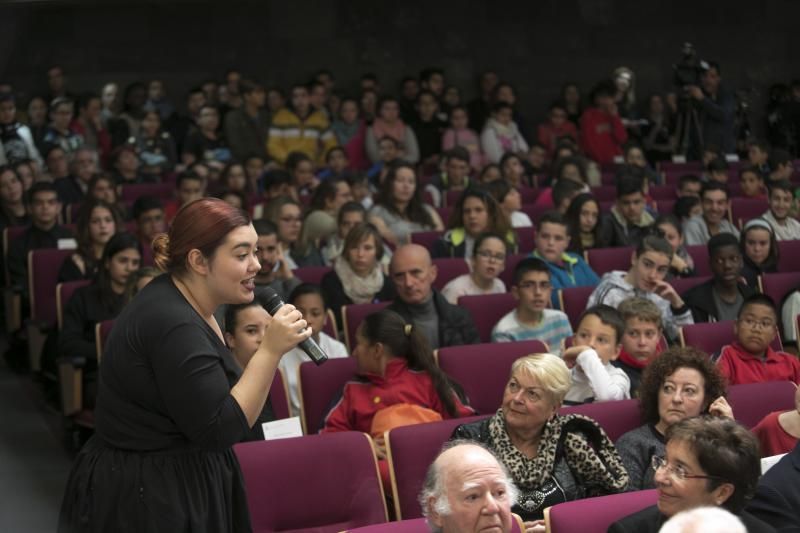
[437,340,548,414]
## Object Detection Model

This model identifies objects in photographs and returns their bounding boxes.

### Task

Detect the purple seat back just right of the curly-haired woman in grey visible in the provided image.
[728,381,797,428]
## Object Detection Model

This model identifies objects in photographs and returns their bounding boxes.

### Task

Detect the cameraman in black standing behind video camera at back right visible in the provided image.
[686,61,736,160]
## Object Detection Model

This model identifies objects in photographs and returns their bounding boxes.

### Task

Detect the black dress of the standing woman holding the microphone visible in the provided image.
[58,275,251,533]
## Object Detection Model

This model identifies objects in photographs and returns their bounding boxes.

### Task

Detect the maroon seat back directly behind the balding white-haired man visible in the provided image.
[385,416,486,520]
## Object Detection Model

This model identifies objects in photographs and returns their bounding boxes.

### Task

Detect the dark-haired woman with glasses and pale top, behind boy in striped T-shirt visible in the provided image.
[442,233,508,305]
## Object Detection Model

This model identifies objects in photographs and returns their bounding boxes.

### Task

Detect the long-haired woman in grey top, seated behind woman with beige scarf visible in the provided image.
[368,163,444,245]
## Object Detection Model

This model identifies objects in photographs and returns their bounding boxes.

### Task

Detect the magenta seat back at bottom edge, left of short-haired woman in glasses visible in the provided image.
[544,489,658,533]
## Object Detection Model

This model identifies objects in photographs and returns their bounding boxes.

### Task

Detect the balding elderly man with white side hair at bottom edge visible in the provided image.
[419,441,517,533]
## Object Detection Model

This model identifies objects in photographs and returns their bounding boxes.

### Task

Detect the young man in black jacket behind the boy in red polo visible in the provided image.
[683,233,756,324]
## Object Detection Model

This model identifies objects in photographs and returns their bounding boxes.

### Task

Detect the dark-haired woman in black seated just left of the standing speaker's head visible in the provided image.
[58,233,142,407]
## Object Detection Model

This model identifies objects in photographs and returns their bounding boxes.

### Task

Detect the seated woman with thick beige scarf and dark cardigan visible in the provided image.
[320,223,394,324]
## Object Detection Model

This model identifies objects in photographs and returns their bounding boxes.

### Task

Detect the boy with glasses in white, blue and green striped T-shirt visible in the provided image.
[492,257,572,354]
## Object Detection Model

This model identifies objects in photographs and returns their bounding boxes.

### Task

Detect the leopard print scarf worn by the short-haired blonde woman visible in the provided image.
[489,409,628,492]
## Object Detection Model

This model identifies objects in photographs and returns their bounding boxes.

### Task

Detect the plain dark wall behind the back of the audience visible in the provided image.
[0,0,800,128]
